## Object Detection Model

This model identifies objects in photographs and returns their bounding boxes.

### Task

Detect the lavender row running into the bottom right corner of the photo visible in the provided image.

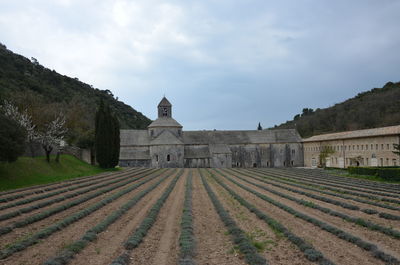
[222,169,400,264]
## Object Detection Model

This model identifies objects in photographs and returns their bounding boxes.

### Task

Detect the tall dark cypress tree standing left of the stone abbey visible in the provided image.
[94,101,120,168]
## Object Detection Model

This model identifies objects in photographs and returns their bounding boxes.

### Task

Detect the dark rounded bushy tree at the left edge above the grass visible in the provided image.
[0,114,26,162]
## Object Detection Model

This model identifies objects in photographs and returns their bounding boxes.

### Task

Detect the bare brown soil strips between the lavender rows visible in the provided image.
[0,168,400,265]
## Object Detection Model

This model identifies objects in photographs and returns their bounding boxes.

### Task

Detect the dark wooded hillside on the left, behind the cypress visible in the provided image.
[0,43,151,144]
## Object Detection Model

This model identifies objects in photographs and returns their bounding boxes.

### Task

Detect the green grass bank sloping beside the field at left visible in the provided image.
[0,155,118,191]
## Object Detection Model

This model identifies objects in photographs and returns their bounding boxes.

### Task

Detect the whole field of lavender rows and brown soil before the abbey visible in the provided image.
[0,168,400,265]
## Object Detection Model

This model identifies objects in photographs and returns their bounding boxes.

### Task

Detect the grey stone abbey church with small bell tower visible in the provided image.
[119,97,304,168]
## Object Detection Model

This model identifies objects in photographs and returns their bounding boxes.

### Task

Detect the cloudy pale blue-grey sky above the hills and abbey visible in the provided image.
[0,0,400,130]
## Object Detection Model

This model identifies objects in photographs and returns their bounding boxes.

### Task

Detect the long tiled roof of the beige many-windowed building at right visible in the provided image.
[303,125,400,142]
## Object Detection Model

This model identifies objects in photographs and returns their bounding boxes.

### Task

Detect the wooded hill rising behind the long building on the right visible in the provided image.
[274,82,400,137]
